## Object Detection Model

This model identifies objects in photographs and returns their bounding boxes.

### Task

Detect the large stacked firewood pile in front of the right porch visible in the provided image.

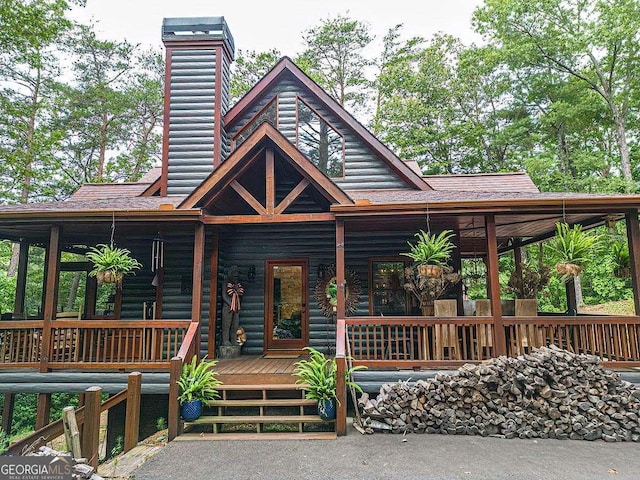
[358,346,640,442]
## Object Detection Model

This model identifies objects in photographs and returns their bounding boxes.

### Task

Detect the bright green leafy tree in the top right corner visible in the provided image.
[474,0,640,188]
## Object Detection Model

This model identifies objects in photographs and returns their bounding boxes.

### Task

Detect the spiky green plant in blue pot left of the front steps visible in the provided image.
[178,355,222,422]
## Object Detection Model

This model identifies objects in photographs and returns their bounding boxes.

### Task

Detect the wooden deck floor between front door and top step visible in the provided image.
[216,356,299,385]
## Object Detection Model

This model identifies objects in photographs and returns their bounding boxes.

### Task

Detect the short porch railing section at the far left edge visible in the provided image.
[0,320,43,368]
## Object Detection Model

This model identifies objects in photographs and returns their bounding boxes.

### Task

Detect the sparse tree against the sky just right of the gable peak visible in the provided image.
[296,15,373,111]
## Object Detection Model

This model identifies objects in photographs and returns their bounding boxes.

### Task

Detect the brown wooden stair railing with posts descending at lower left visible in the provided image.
[7,372,142,467]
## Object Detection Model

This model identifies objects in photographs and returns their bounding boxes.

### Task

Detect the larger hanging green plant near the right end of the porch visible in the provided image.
[547,222,600,281]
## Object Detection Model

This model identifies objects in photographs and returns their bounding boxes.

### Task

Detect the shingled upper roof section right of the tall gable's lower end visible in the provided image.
[423,172,540,193]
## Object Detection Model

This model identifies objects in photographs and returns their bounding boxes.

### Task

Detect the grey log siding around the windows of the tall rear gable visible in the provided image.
[222,73,406,190]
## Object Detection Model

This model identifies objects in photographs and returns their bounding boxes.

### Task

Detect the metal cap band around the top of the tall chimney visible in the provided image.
[162,17,235,53]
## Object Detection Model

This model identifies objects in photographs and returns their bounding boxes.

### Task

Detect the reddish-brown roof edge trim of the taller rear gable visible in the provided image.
[224,57,430,190]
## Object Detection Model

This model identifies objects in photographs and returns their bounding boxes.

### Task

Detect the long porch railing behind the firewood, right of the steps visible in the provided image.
[345,316,640,368]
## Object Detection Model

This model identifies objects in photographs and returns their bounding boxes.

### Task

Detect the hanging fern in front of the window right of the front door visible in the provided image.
[400,230,456,278]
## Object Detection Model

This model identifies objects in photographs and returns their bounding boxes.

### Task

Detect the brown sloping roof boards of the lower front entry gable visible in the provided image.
[178,122,353,209]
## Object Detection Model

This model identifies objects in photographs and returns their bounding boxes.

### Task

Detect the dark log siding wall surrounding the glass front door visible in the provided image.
[218,223,335,355]
